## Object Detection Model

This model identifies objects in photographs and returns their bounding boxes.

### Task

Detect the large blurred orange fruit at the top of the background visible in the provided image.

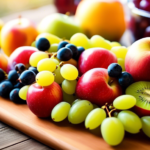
[75,0,126,41]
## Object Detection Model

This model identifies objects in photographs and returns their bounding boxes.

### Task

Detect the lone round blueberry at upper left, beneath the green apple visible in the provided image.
[36,37,50,51]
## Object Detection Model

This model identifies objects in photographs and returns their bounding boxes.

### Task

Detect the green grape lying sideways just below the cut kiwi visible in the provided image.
[113,95,136,110]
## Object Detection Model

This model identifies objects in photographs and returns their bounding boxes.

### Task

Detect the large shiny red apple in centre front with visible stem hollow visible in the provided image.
[76,68,122,106]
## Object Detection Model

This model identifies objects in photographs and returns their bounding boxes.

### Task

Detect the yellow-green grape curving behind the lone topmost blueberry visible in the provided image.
[36,33,62,44]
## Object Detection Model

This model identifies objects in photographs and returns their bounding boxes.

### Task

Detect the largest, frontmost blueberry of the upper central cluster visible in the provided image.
[57,47,73,61]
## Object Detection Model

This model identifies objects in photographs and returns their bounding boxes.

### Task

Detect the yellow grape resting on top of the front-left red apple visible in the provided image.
[36,71,54,86]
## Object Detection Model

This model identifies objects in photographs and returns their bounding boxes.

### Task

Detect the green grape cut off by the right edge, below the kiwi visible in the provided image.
[141,116,150,138]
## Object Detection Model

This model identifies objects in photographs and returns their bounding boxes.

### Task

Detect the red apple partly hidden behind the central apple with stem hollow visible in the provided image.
[78,48,117,75]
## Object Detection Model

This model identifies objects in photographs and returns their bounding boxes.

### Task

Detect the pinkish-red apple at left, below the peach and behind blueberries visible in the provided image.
[7,46,38,72]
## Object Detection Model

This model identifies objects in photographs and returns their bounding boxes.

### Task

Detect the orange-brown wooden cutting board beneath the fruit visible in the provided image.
[0,98,150,150]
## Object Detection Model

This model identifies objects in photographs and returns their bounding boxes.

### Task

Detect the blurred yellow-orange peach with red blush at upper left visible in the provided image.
[1,18,38,56]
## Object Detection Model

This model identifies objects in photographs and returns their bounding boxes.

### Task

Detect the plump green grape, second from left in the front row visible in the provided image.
[68,100,93,124]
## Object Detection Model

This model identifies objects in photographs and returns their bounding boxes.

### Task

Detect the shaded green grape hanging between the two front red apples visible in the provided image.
[61,80,77,95]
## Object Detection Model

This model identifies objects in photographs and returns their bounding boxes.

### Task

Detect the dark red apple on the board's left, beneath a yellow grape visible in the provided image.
[27,82,63,117]
